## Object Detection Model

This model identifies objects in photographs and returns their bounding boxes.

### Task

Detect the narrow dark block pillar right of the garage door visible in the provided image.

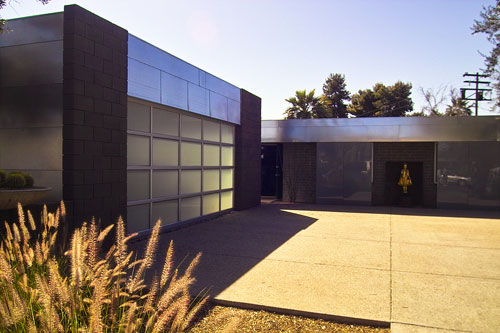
[234,89,261,210]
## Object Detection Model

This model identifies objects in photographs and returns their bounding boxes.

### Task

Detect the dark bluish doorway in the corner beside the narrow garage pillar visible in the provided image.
[260,144,283,199]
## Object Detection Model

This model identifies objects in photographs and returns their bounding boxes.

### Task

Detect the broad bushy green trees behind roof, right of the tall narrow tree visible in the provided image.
[347,81,413,117]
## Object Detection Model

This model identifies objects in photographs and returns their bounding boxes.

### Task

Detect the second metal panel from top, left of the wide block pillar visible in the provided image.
[0,41,63,87]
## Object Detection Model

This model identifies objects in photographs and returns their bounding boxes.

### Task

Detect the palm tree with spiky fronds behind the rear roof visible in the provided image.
[285,89,328,119]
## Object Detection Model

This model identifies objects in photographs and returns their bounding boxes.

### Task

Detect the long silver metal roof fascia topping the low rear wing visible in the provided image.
[261,116,500,143]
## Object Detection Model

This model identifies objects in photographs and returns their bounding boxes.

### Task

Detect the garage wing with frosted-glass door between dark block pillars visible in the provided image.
[0,5,261,232]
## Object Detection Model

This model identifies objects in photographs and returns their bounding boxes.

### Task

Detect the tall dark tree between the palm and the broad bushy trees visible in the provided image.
[321,74,351,118]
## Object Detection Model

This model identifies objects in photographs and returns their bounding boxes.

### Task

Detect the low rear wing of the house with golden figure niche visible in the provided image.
[262,116,500,210]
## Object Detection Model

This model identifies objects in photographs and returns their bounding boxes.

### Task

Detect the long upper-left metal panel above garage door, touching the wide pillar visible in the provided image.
[128,34,199,84]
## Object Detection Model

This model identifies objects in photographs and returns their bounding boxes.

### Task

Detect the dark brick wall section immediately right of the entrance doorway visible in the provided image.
[283,143,316,203]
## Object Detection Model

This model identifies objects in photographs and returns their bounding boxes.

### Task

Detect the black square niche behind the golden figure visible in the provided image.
[385,161,423,207]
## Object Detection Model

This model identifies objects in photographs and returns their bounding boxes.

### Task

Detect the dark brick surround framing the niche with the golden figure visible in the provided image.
[372,142,437,207]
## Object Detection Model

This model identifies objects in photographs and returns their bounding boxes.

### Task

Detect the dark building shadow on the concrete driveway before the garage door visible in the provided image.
[132,204,316,297]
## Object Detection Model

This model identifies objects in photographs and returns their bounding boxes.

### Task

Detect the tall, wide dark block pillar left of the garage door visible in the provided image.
[63,5,128,225]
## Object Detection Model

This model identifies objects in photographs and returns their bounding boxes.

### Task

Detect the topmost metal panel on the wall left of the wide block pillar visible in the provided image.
[0,13,64,47]
